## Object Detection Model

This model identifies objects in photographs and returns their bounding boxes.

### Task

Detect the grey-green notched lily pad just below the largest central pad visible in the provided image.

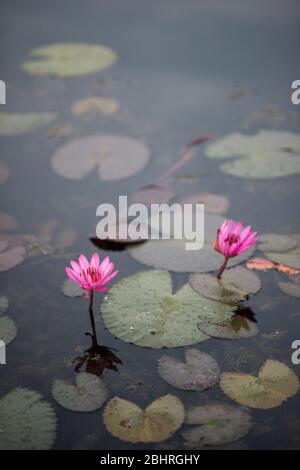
[158,349,220,391]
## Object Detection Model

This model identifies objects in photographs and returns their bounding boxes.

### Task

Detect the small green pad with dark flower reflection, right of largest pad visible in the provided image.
[198,314,258,339]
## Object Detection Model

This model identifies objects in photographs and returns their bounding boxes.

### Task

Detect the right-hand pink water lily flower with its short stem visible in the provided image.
[214,220,257,279]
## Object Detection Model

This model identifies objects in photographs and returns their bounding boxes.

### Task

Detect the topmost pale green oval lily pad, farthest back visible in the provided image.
[21,42,117,78]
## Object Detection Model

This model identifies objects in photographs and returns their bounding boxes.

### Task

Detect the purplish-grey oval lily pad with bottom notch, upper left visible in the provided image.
[51,135,150,181]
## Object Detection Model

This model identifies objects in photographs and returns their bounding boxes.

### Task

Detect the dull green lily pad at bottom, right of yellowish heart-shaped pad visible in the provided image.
[183,404,253,449]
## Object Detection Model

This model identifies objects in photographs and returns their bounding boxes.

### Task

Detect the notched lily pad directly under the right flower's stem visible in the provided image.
[189,266,261,304]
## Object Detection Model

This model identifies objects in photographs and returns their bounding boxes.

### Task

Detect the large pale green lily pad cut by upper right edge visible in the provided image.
[206,131,300,179]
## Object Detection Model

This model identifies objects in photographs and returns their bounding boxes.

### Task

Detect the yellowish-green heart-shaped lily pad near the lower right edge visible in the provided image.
[220,359,299,410]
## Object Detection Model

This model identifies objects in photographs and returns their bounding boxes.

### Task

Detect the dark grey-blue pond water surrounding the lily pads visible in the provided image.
[0,0,300,449]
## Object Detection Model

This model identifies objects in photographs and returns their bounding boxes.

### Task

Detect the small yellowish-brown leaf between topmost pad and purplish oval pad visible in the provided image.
[71,96,119,116]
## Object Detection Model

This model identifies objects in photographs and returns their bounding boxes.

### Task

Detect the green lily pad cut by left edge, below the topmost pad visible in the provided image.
[0,113,57,136]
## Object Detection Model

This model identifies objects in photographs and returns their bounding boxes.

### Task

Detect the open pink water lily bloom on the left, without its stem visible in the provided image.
[65,253,118,297]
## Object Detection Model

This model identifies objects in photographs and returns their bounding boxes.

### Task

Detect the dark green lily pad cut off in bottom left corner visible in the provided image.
[0,387,56,450]
